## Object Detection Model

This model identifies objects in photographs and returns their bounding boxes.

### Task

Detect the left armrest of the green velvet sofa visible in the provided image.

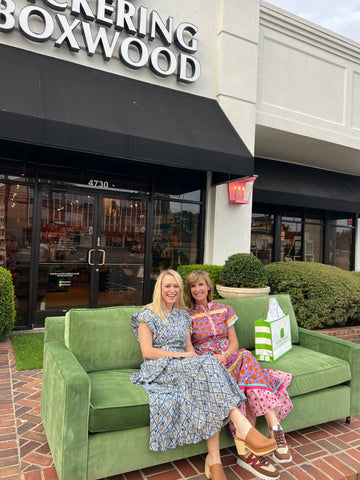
[41,341,90,480]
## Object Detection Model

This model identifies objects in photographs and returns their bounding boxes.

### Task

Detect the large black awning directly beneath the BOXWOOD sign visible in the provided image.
[0,45,254,176]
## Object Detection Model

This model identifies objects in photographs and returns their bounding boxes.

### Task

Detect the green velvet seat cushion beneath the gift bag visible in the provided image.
[260,345,351,397]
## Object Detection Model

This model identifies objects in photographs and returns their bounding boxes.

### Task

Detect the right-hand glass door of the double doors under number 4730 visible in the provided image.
[96,194,146,306]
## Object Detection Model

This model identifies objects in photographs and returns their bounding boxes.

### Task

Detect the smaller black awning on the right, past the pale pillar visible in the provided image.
[253,158,360,213]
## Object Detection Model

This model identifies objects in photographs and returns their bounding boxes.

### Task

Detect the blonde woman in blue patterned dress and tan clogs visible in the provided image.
[130,270,276,480]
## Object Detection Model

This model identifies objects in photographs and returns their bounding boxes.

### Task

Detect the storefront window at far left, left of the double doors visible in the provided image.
[0,183,33,326]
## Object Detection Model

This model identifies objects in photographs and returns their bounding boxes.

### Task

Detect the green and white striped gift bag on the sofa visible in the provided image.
[255,298,291,362]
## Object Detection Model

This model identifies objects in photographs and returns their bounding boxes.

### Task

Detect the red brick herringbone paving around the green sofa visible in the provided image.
[0,340,360,480]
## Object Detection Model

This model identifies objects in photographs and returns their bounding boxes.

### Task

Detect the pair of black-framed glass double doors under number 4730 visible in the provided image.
[36,189,146,322]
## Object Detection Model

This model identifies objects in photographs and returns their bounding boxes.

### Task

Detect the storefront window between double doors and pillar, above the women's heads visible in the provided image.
[152,199,200,277]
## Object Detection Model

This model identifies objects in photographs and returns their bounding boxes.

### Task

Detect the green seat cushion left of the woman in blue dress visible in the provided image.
[89,369,150,433]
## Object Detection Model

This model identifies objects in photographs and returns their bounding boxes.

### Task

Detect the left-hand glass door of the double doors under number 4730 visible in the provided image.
[36,191,95,311]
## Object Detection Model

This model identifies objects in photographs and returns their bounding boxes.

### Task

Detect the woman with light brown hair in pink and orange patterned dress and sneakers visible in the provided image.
[185,270,293,479]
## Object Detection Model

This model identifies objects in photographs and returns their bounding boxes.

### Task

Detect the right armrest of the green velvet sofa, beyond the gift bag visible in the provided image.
[299,327,360,415]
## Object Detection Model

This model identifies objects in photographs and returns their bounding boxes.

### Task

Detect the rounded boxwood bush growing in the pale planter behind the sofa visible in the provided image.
[219,253,268,288]
